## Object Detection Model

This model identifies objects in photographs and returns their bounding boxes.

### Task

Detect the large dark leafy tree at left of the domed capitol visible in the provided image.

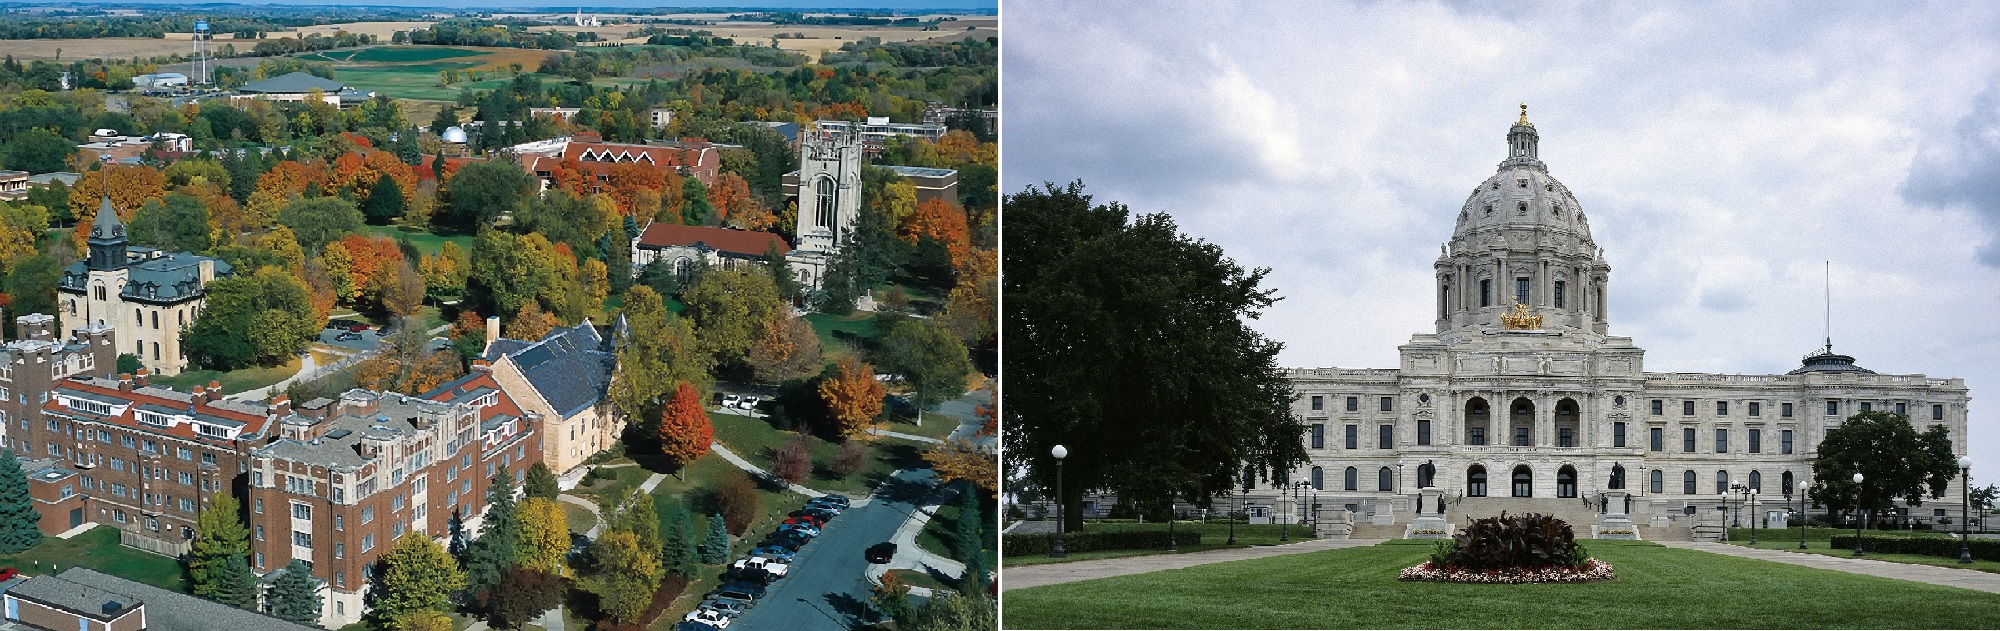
[1000,184,1306,527]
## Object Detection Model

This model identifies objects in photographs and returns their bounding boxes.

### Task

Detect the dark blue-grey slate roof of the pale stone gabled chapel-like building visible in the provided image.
[486,319,618,419]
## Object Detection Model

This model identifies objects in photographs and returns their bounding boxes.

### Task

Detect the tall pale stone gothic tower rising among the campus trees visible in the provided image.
[792,130,862,254]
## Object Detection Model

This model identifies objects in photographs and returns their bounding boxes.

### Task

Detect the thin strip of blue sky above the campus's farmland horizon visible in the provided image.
[8,0,1000,14]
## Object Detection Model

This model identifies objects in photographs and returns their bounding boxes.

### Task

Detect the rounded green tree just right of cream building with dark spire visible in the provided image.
[180,268,320,369]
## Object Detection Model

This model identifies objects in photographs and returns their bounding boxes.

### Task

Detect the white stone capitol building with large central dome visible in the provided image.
[1272,106,1968,539]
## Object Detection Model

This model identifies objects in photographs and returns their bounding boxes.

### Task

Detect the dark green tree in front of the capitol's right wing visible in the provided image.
[1816,409,1958,519]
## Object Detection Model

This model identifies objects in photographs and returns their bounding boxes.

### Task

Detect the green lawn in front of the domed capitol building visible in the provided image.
[1002,541,2000,629]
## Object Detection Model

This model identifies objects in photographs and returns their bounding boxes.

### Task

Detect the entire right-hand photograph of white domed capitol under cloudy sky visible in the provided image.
[1000,2,2000,629]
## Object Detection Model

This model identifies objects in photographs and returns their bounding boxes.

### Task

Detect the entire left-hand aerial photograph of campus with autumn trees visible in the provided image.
[0,2,1000,631]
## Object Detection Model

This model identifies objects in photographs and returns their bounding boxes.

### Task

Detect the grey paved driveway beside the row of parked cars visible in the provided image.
[730,469,934,631]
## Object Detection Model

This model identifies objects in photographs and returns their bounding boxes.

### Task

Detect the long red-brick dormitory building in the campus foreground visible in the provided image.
[0,314,542,629]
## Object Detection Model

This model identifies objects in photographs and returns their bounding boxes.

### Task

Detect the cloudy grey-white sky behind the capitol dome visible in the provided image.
[1002,0,2000,473]
